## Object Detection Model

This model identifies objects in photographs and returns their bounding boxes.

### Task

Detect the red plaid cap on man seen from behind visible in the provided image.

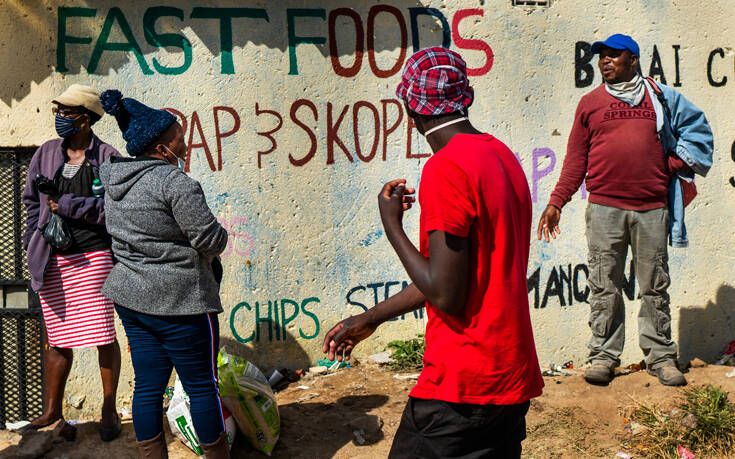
[396,46,475,115]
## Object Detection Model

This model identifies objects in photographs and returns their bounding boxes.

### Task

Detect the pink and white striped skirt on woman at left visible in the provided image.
[38,250,115,348]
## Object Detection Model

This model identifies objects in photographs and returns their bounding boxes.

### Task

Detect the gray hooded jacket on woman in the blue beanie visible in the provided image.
[100,157,227,316]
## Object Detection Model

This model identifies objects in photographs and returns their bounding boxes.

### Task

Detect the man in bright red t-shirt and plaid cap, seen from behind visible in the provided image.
[324,48,543,458]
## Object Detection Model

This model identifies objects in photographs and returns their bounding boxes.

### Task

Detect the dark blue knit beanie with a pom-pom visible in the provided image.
[100,89,176,156]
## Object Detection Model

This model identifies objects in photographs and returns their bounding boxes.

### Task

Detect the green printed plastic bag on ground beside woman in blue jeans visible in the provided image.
[217,351,281,456]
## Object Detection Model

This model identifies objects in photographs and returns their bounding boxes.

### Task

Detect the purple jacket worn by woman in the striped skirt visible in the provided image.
[23,134,120,291]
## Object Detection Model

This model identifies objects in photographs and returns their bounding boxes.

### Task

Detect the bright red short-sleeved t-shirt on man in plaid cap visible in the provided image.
[411,134,544,405]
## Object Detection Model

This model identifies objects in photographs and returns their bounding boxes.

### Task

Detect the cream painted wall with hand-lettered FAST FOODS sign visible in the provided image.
[0,0,735,415]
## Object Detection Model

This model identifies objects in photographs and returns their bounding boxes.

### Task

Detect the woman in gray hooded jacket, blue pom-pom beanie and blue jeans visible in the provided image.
[100,90,229,458]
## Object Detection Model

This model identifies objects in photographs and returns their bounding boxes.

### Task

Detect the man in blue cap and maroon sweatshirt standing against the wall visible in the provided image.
[538,34,713,386]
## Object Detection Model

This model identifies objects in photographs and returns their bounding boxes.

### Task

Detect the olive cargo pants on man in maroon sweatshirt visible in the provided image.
[585,203,677,369]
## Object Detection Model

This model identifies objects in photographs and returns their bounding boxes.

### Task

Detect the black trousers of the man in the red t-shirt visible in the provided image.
[388,397,530,459]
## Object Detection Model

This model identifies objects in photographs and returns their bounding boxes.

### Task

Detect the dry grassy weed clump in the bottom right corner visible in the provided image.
[631,385,735,458]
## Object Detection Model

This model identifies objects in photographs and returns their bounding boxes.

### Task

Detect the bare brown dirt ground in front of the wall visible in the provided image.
[0,364,735,459]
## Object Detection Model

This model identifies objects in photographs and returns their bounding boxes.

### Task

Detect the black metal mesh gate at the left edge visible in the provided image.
[0,147,44,428]
